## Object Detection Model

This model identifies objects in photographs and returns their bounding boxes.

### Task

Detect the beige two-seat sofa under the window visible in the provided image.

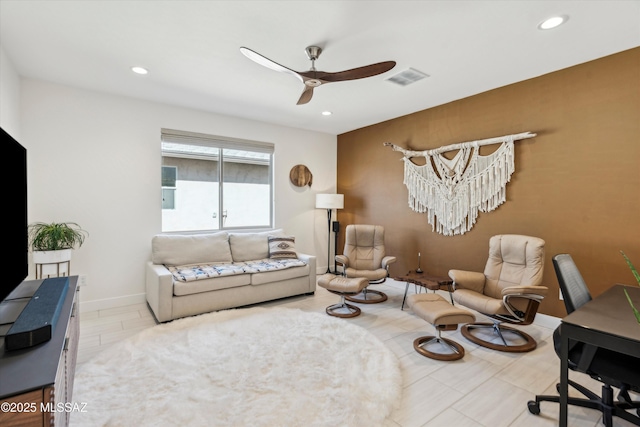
[146,230,316,322]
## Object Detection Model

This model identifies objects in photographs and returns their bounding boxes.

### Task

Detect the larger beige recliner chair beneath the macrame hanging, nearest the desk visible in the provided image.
[449,234,548,352]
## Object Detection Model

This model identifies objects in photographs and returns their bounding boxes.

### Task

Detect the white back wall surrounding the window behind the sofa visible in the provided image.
[21,79,337,311]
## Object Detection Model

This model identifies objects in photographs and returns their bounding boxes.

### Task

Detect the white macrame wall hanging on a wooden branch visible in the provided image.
[384,132,536,236]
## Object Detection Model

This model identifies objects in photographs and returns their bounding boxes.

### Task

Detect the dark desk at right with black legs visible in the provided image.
[560,285,640,427]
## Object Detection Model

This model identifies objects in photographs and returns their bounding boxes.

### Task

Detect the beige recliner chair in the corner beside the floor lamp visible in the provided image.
[336,224,396,304]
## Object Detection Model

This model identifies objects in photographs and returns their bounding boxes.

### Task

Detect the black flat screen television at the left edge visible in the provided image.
[0,128,29,303]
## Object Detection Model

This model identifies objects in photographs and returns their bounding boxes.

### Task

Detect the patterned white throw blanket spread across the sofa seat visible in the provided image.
[165,258,307,282]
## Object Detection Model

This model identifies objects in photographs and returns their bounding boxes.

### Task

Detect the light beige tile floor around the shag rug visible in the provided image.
[78,280,637,427]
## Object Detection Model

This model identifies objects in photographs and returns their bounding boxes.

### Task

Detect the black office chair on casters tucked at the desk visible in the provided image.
[527,254,640,427]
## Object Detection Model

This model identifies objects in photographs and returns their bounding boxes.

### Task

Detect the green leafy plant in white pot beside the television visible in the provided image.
[29,222,89,273]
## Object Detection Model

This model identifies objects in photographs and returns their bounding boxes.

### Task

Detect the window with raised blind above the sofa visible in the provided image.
[162,129,273,232]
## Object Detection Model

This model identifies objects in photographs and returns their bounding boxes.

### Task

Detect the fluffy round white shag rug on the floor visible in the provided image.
[71,307,402,427]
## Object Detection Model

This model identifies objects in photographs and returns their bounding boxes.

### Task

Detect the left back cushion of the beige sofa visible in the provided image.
[151,231,232,266]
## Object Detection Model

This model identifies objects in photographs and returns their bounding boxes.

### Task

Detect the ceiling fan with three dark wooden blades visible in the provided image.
[240,46,396,105]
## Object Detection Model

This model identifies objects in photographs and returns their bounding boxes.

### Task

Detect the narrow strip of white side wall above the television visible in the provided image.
[0,46,20,136]
